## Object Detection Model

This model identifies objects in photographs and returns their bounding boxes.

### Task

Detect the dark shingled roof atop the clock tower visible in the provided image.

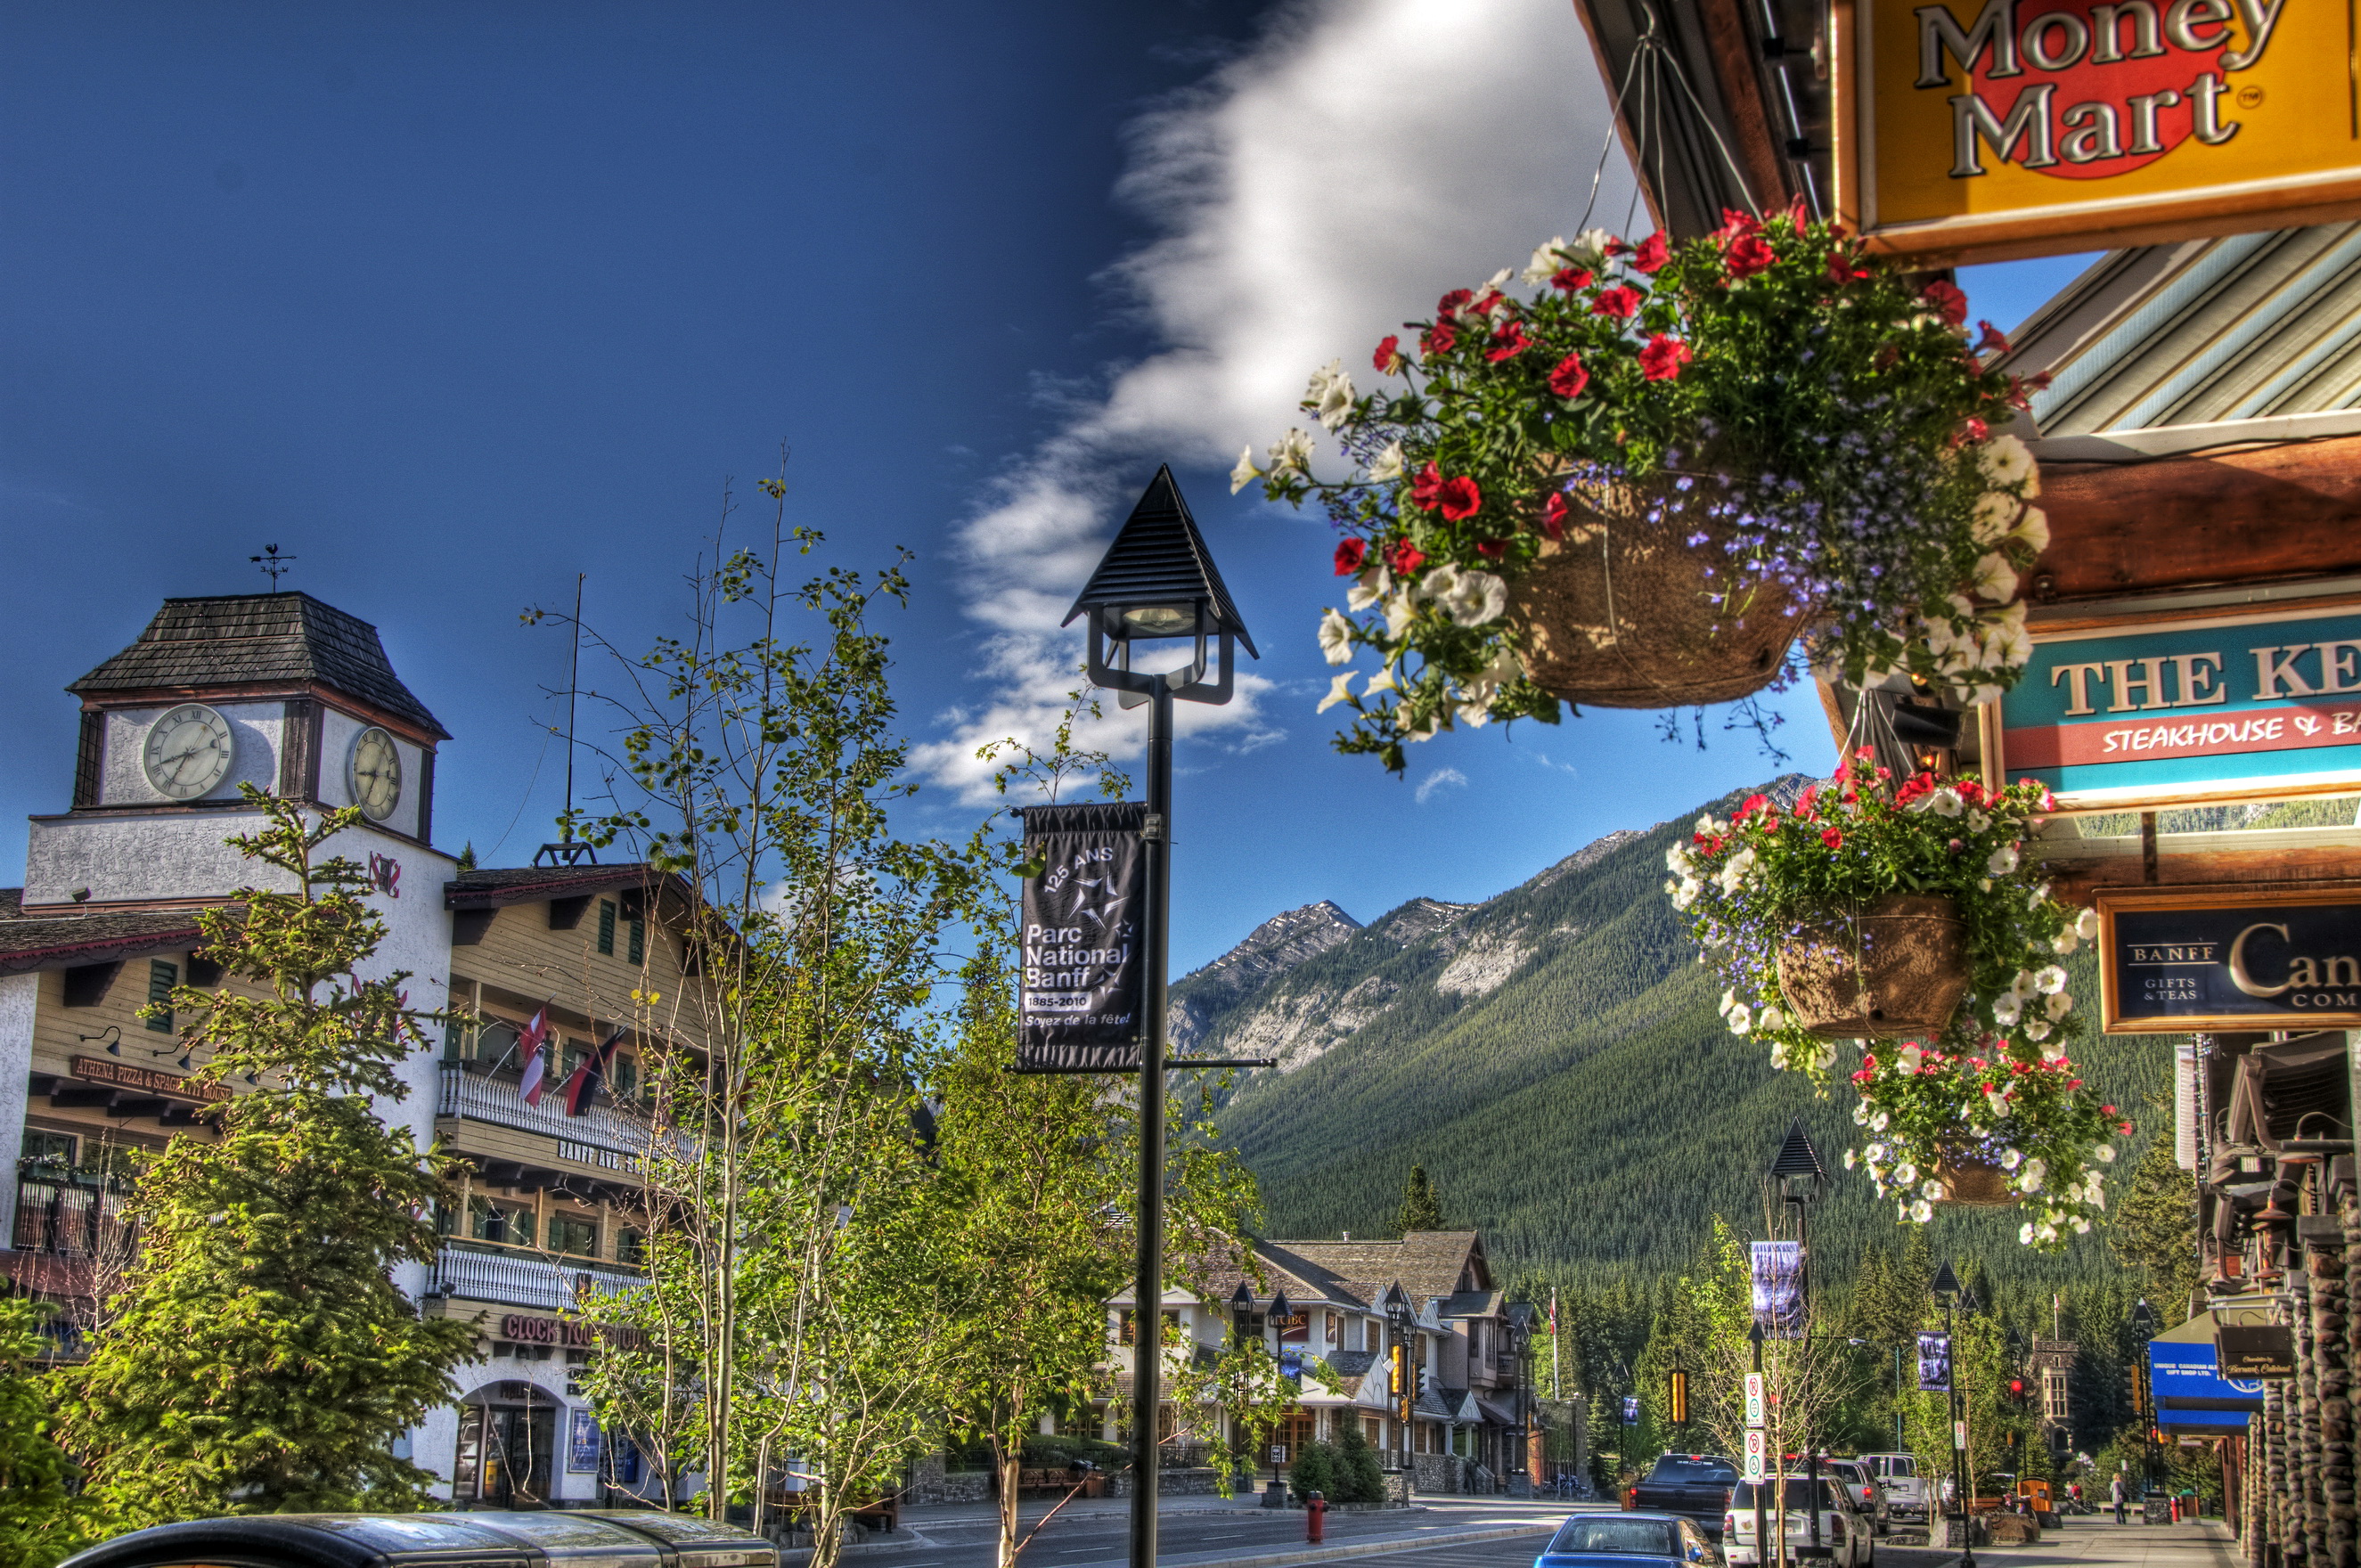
[66,592,451,739]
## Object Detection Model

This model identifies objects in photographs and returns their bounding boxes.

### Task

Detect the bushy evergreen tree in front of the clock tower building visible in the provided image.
[59,787,475,1525]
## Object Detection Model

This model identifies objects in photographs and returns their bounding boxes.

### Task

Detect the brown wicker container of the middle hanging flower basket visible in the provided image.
[1777,893,1966,1039]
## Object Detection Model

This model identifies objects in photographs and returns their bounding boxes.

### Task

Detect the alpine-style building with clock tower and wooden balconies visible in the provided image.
[0,592,698,1507]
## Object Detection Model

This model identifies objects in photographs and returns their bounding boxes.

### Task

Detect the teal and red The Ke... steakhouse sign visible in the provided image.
[1986,600,2361,813]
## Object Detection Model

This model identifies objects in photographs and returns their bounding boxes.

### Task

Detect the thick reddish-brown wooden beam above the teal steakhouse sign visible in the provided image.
[2028,435,2361,605]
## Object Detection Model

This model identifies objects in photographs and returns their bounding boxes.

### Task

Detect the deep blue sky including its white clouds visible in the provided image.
[0,0,2105,970]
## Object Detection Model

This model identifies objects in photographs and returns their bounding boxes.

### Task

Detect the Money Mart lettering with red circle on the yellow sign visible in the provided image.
[1913,0,2288,179]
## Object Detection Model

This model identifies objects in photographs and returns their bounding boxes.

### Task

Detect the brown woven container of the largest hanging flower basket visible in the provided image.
[1508,475,1811,708]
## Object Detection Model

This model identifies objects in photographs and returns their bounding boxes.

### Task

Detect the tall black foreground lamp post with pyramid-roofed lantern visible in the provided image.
[1065,468,1261,1568]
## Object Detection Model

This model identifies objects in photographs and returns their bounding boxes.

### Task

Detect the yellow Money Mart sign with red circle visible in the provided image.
[1837,0,2361,260]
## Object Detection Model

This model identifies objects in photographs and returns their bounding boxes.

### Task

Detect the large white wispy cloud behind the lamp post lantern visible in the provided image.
[916,0,1630,798]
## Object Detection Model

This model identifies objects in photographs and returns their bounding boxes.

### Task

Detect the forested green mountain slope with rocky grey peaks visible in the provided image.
[1199,780,2175,1278]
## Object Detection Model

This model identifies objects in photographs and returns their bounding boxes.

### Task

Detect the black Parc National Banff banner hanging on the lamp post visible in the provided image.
[1016,803,1148,1072]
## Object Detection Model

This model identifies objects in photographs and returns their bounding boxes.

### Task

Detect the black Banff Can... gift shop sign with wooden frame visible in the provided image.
[2096,888,2361,1034]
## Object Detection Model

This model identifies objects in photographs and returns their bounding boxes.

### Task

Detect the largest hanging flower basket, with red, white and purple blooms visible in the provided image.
[1230,208,2049,772]
